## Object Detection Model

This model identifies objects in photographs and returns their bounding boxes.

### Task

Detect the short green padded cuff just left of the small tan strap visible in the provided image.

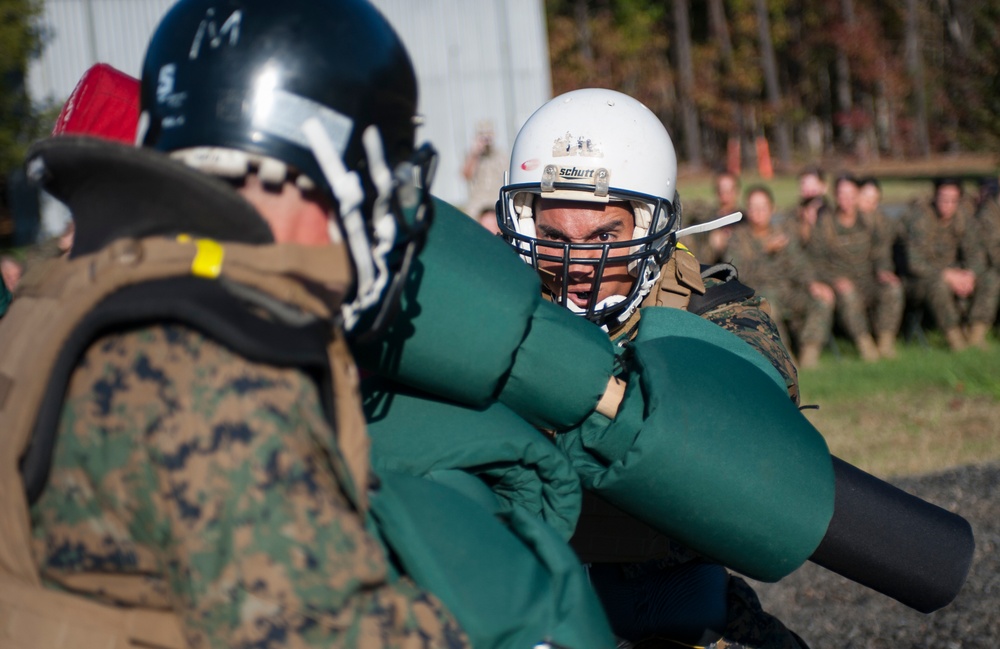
[499,300,615,430]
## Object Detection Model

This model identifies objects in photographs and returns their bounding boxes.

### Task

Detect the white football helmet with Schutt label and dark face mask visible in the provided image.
[498,88,680,326]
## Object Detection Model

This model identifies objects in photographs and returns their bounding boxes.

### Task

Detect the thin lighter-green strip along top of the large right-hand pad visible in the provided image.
[635,307,788,390]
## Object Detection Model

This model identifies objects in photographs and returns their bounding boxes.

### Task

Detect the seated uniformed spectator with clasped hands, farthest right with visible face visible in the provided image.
[906,178,1000,350]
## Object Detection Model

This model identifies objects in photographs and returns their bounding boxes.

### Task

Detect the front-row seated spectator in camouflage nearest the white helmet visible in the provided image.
[729,185,835,369]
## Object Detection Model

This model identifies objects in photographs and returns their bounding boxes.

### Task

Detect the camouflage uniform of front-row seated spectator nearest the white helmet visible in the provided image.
[729,221,833,348]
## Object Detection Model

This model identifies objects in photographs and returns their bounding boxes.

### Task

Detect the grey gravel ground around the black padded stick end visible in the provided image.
[751,464,1000,649]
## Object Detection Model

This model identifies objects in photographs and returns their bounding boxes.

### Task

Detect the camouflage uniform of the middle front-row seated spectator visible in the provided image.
[809,212,905,340]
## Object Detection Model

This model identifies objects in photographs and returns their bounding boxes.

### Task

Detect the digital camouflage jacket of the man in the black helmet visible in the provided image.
[31,325,467,647]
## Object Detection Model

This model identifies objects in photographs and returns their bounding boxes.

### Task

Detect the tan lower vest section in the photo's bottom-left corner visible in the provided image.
[0,575,188,649]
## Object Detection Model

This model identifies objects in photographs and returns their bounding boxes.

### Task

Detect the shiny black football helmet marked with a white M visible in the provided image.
[138,0,436,330]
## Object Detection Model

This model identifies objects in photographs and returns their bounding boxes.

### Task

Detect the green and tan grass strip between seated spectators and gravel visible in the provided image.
[799,333,1000,477]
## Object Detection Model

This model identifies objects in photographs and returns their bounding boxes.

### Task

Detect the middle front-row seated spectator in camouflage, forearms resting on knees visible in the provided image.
[810,174,904,361]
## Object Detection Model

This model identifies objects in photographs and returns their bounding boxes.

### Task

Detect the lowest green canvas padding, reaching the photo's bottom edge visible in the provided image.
[371,470,615,649]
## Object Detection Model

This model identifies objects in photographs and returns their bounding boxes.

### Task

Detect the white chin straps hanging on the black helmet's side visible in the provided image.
[302,117,396,331]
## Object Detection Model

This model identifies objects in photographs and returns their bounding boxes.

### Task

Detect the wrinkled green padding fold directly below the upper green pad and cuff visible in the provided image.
[362,379,581,541]
